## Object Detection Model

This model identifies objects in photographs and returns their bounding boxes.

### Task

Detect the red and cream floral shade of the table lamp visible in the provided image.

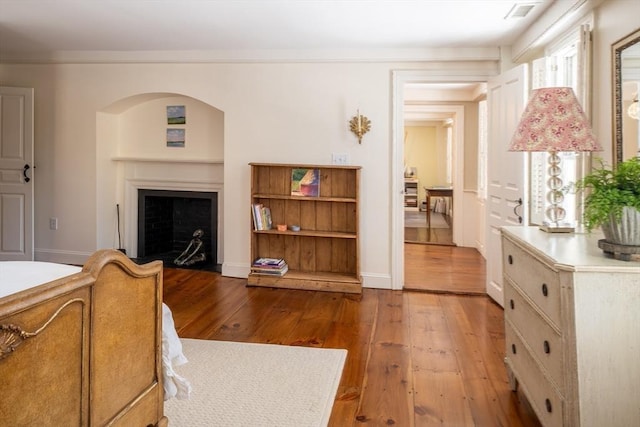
[509,87,602,152]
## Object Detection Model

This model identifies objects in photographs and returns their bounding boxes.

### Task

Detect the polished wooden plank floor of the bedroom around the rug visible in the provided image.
[164,255,539,427]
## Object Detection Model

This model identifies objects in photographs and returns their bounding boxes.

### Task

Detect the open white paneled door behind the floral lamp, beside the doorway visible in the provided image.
[486,65,528,306]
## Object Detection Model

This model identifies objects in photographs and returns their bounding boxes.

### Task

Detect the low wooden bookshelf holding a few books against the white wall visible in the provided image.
[247,163,362,293]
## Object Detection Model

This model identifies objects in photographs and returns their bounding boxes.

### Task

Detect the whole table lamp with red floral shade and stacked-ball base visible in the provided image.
[509,87,602,233]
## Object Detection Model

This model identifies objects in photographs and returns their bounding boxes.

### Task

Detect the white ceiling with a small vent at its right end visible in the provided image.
[0,0,552,61]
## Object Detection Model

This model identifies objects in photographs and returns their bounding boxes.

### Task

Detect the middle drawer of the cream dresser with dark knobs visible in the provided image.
[504,280,564,393]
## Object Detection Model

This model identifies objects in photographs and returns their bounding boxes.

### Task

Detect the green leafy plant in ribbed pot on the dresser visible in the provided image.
[577,157,640,246]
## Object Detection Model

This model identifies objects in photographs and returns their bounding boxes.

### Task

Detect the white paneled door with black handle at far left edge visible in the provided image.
[0,87,33,261]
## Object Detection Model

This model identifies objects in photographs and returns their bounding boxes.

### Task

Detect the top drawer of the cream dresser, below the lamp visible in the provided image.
[502,239,560,328]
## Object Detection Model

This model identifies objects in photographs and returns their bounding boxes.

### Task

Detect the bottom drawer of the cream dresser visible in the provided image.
[505,322,564,427]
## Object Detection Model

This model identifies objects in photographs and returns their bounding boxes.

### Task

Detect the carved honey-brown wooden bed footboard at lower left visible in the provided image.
[0,250,168,427]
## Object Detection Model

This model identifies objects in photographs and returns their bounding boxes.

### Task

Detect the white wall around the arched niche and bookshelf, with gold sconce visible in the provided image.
[0,63,492,286]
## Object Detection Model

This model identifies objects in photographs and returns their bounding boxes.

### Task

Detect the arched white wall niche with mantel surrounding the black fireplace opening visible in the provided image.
[96,92,224,263]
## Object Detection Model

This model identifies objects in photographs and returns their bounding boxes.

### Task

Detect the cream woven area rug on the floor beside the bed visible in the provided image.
[165,338,347,427]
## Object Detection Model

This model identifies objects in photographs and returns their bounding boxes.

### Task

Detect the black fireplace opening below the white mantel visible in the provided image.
[137,189,220,271]
